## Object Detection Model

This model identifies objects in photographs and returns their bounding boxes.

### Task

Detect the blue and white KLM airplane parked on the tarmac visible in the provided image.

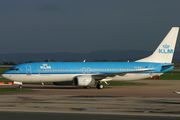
[2,27,179,89]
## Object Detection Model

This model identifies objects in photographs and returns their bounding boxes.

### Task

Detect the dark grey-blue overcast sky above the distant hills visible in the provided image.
[0,0,180,54]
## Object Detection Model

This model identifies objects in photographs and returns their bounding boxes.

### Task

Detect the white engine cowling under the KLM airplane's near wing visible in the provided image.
[74,75,95,87]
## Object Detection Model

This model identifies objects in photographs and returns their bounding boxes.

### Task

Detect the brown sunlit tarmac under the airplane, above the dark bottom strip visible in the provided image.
[0,80,180,117]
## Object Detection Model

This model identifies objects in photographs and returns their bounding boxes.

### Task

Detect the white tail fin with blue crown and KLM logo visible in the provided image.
[135,27,179,63]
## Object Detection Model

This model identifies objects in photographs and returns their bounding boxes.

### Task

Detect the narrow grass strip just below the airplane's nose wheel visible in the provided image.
[0,88,33,93]
